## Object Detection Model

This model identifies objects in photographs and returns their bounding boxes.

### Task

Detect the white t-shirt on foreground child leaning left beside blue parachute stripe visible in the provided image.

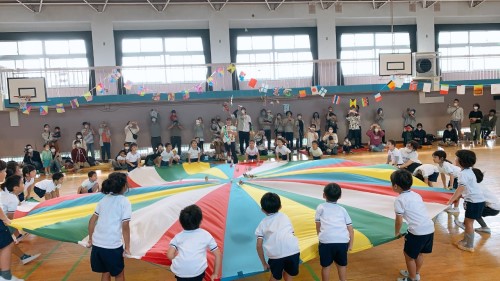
[255,212,300,259]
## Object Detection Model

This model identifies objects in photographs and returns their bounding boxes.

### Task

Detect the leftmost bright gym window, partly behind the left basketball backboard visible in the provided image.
[0,39,89,87]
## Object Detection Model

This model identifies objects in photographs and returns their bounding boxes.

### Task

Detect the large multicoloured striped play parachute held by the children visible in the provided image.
[12,159,451,280]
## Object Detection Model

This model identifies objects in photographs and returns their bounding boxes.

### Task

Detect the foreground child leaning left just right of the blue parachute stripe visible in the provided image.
[255,192,300,281]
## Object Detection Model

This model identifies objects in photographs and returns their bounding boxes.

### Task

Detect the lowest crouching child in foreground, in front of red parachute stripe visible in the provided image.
[167,205,222,281]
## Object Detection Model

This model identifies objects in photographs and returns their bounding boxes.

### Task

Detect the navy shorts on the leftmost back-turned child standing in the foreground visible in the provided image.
[90,243,125,277]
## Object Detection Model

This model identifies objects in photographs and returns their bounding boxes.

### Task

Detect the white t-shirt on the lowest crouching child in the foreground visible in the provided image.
[170,228,218,278]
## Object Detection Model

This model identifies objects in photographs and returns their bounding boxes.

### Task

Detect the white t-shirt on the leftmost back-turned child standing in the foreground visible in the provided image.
[92,194,132,249]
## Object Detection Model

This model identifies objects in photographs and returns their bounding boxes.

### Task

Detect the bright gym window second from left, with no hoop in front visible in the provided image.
[122,37,207,83]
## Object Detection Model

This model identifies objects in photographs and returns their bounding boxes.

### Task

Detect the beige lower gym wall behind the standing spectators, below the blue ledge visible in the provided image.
[0,89,496,157]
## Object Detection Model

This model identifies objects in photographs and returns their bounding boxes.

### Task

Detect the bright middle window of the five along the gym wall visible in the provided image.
[236,35,313,80]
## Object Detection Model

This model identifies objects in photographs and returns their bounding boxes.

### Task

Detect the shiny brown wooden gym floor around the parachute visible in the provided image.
[12,141,500,281]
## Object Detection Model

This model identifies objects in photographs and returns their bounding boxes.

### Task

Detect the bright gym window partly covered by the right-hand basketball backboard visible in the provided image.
[340,32,411,76]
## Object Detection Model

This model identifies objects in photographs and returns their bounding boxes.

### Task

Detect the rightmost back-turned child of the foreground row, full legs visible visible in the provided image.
[391,170,434,281]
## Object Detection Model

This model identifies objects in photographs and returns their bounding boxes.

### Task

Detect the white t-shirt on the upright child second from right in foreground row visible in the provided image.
[315,202,352,244]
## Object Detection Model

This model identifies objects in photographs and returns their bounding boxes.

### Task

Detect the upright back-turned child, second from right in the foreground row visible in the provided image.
[315,183,354,281]
